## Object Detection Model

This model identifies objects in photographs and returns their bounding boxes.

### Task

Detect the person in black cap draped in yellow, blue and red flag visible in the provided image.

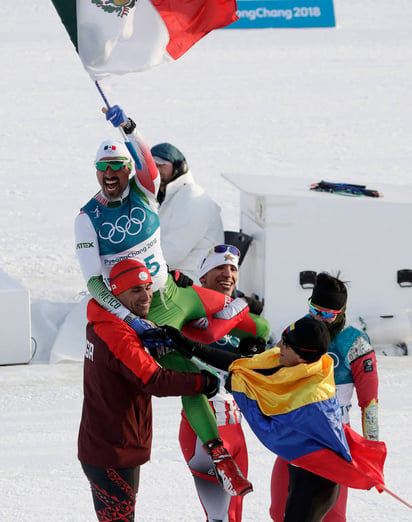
[164,317,386,522]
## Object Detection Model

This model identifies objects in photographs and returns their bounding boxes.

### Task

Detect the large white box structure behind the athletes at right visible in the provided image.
[224,174,412,335]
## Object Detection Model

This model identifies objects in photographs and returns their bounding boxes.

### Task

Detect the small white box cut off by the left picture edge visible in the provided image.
[0,270,32,365]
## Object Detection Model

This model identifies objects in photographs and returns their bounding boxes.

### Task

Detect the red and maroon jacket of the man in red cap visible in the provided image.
[78,299,202,468]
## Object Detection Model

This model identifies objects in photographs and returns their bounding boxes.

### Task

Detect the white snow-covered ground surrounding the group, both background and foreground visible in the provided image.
[0,0,412,522]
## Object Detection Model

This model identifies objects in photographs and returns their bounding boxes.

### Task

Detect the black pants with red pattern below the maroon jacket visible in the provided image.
[81,462,140,522]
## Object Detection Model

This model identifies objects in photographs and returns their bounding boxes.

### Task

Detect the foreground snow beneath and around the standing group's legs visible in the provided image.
[0,356,412,522]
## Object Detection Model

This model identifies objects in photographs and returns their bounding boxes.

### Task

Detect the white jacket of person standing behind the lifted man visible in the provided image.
[159,171,224,284]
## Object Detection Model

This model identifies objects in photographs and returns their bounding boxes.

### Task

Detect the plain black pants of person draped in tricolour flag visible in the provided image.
[283,464,340,522]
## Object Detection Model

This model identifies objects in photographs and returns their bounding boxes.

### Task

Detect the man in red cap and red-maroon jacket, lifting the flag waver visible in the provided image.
[78,260,218,521]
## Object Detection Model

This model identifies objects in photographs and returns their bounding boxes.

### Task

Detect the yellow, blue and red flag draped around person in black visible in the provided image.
[229,348,386,490]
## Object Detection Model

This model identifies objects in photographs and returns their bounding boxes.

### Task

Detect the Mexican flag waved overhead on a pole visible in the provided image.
[52,0,238,80]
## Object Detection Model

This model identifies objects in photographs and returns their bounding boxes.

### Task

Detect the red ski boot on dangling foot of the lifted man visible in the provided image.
[205,439,253,497]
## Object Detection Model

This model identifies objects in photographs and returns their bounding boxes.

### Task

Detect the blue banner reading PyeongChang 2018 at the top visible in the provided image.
[227,0,336,29]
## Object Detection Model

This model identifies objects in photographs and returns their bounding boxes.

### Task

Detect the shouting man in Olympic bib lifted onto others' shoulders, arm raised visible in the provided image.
[75,102,269,496]
